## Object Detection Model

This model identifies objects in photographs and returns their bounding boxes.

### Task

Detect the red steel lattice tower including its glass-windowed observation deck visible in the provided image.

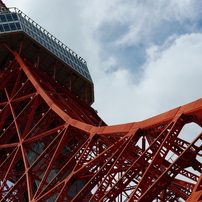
[0,2,202,202]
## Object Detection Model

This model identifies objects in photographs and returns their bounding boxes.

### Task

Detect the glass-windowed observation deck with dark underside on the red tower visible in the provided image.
[0,8,94,104]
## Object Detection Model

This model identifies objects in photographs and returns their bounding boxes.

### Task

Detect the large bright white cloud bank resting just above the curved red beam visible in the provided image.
[92,34,202,124]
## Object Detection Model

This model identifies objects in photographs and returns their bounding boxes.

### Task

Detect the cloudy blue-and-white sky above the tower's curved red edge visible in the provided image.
[4,0,202,125]
